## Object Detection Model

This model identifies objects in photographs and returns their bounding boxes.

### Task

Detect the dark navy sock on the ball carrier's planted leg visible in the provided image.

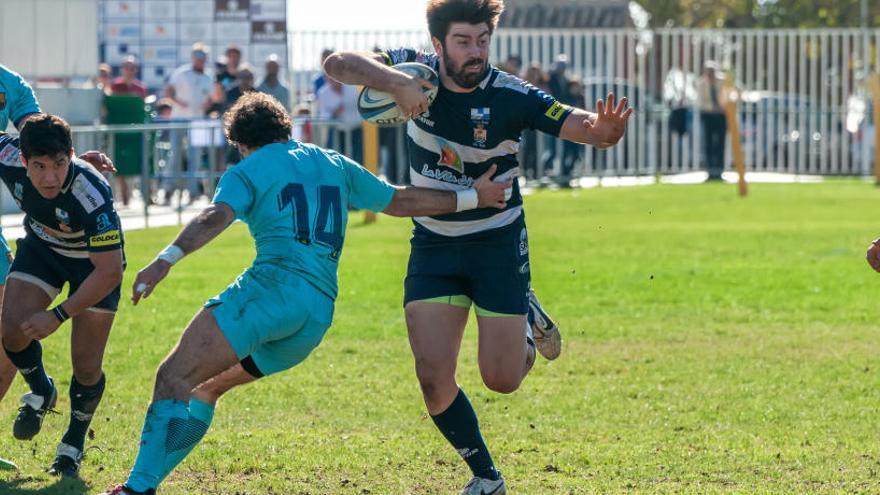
[431,389,500,480]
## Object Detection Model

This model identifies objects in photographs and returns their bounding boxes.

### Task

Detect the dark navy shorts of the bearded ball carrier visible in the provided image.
[404,215,531,315]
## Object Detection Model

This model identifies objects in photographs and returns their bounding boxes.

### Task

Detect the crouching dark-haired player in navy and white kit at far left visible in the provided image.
[0,115,125,476]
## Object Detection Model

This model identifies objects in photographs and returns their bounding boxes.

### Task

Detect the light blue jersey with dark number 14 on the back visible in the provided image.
[214,141,394,299]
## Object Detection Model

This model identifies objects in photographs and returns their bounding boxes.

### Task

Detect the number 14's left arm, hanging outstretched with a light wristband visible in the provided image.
[131,203,235,305]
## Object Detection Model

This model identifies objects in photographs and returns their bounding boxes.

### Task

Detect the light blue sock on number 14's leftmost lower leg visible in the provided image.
[125,400,189,492]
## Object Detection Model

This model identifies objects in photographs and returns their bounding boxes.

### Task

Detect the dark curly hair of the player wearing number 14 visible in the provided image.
[223,91,293,149]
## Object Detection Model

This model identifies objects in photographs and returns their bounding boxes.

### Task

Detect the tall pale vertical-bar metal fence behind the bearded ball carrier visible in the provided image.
[291,29,880,176]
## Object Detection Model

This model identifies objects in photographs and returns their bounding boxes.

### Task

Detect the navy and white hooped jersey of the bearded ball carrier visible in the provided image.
[382,48,572,237]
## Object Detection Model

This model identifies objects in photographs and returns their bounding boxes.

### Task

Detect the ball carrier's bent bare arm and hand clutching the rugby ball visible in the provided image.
[324,52,433,116]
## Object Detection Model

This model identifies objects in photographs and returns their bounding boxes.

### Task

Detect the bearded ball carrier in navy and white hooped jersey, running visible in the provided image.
[324,0,632,494]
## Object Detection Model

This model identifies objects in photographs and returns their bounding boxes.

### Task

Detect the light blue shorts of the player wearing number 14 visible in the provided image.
[205,265,333,375]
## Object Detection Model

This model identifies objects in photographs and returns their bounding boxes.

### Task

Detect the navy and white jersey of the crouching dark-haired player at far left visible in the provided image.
[0,134,123,258]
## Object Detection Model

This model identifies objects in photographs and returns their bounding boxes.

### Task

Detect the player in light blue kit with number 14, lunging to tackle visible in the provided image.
[98,93,511,495]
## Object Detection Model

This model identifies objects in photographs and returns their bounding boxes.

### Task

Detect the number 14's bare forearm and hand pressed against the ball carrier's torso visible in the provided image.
[382,165,512,217]
